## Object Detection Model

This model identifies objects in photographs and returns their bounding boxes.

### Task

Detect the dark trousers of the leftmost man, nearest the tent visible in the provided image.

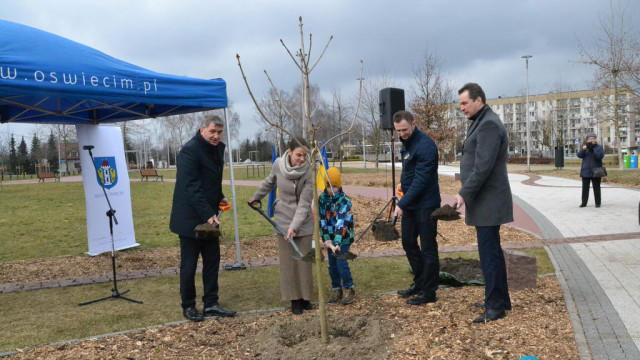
[180,236,220,309]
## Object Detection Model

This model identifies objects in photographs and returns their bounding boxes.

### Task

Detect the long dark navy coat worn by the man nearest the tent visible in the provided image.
[169,131,225,238]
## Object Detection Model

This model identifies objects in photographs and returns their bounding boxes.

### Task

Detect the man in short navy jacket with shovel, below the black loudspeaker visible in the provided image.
[393,110,440,305]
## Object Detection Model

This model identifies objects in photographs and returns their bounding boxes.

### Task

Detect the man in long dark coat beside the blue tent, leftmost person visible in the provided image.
[169,115,236,321]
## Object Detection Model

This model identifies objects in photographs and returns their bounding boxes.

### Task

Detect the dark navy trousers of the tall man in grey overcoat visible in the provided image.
[476,225,511,310]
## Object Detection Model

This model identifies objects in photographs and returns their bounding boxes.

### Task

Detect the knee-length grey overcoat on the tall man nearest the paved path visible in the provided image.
[459,105,513,226]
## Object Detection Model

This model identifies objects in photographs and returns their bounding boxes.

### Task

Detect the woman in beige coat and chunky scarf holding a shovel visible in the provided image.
[249,137,314,315]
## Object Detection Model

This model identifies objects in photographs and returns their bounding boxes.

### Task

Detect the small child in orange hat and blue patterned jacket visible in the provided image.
[318,167,356,305]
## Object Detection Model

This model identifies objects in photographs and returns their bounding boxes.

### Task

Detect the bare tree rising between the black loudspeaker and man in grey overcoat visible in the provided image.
[409,52,460,159]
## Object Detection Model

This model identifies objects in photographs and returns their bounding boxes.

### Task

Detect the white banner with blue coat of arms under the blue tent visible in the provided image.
[76,125,140,255]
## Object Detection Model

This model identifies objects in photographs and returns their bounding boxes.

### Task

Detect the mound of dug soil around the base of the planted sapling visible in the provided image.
[247,314,393,359]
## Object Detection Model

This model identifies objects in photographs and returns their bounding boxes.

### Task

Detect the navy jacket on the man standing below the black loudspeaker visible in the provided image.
[398,127,440,210]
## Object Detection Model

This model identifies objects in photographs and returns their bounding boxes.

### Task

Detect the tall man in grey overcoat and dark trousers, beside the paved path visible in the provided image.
[455,83,513,323]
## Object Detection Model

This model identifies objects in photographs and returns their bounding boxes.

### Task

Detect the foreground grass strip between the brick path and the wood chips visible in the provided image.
[0,249,553,353]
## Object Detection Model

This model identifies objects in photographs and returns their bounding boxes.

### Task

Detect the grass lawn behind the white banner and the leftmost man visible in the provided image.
[0,181,273,261]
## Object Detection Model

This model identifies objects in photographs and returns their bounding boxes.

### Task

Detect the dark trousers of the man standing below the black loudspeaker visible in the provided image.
[402,208,440,296]
